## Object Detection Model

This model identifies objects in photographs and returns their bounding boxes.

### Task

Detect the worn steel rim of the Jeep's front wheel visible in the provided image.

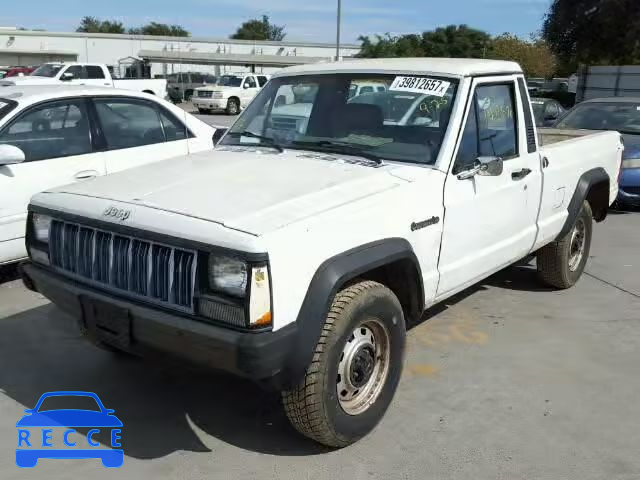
[336,319,391,415]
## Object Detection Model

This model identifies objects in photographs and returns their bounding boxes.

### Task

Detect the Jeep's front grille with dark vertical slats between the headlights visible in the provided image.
[49,220,197,313]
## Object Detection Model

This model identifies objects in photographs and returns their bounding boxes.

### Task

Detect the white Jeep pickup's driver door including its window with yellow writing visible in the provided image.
[437,76,542,297]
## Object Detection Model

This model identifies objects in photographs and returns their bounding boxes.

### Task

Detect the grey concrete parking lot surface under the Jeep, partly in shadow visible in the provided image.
[0,213,640,480]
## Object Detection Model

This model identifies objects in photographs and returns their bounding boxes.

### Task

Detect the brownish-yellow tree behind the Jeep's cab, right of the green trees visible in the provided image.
[489,33,556,78]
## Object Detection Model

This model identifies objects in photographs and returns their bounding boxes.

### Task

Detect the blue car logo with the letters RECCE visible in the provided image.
[16,391,124,468]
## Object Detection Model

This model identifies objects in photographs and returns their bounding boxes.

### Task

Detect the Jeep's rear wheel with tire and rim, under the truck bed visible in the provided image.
[537,201,593,289]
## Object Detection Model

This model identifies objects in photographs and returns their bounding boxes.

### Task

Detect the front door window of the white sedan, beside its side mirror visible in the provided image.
[0,100,92,162]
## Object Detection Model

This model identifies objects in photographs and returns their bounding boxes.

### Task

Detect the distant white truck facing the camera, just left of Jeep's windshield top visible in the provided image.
[191,73,269,115]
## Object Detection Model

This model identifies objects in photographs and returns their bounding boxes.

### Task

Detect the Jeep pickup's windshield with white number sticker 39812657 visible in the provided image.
[221,74,458,164]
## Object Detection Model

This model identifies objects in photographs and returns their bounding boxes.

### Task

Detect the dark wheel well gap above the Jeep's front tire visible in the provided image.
[352,259,424,325]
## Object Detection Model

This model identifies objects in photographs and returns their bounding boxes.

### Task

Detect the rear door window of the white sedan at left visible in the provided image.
[94,98,166,150]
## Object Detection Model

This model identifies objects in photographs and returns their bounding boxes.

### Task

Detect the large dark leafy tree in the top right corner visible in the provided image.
[542,0,640,67]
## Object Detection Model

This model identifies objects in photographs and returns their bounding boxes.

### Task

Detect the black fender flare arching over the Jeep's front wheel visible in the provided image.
[287,238,424,385]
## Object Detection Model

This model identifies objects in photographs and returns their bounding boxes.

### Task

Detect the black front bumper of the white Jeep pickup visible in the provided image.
[21,262,296,389]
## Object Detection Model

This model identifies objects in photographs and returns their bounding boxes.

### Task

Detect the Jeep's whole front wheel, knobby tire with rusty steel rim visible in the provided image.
[282,281,405,447]
